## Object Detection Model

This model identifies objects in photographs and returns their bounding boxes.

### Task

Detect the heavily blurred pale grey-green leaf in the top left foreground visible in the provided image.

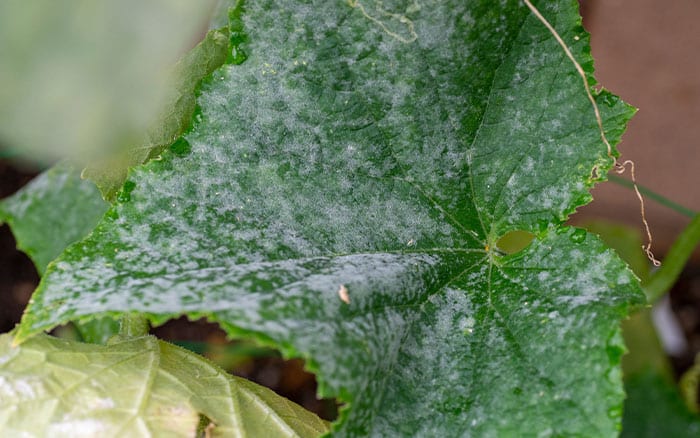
[0,0,215,163]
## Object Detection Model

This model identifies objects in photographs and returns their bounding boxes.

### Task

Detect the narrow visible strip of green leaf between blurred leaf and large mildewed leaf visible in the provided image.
[83,28,230,201]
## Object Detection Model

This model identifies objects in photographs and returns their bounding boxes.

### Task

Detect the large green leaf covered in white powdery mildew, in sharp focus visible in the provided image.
[17,0,644,436]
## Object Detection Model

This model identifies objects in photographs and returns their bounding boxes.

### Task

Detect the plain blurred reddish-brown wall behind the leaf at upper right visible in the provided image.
[573,0,700,256]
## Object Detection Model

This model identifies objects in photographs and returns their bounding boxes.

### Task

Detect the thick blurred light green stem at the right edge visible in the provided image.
[643,214,700,304]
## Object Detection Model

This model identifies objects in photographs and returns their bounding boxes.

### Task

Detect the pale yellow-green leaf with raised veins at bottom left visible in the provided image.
[0,334,328,437]
